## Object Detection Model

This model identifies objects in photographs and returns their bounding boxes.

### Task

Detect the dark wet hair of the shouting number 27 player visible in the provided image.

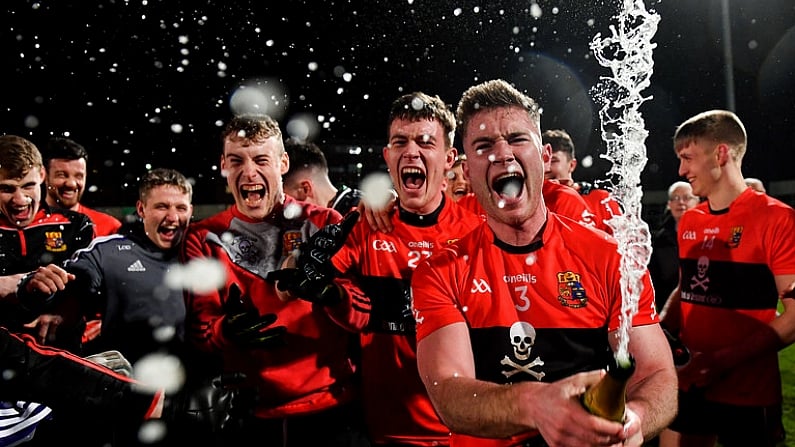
[387,92,456,147]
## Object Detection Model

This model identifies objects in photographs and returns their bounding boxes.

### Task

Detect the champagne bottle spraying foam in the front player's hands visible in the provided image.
[582,355,635,422]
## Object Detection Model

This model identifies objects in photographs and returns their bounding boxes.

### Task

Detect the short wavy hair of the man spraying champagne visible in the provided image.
[456,79,541,136]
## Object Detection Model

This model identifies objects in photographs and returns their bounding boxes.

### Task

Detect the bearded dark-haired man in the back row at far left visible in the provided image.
[42,137,121,236]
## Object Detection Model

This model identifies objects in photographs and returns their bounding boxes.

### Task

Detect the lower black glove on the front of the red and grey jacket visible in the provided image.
[221,284,287,348]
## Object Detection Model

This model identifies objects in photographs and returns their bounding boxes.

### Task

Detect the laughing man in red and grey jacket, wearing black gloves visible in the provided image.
[183,115,360,446]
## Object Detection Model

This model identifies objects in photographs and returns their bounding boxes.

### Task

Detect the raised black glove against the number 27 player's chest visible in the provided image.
[265,210,359,305]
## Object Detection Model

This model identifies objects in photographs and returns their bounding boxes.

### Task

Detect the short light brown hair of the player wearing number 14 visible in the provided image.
[674,110,748,161]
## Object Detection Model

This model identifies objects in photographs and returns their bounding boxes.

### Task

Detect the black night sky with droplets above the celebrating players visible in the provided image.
[0,0,795,220]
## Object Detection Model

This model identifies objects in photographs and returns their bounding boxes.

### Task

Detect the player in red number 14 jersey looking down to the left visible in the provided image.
[660,110,795,447]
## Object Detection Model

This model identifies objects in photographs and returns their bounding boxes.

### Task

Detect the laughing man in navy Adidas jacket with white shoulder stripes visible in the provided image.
[29,169,193,363]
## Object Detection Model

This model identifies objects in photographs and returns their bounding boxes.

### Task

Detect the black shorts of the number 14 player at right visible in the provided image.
[668,391,784,447]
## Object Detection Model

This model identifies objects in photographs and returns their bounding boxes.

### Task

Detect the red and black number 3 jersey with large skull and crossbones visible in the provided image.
[411,214,658,446]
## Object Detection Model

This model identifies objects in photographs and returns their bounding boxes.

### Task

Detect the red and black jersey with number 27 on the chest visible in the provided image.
[332,197,482,446]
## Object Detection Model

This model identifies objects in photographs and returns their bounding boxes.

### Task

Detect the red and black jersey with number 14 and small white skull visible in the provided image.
[678,188,795,405]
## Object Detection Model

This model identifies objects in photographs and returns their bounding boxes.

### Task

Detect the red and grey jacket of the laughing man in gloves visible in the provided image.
[182,197,356,418]
